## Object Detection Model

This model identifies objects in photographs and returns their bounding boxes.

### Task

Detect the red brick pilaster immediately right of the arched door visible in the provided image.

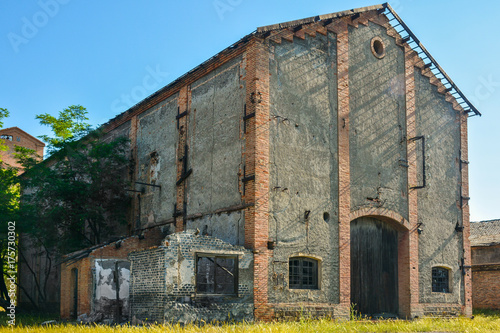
[404,44,419,317]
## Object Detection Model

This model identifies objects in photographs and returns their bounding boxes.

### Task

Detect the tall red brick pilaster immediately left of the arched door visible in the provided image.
[328,19,351,316]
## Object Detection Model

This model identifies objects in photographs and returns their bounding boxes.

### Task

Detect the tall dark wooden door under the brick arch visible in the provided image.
[351,217,398,318]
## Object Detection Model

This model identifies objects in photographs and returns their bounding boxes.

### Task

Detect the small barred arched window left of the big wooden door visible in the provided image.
[288,257,318,289]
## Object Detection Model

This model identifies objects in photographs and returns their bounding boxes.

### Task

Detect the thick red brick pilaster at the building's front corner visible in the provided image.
[244,39,274,320]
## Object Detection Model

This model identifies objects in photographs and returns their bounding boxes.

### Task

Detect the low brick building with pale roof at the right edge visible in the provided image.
[470,220,500,310]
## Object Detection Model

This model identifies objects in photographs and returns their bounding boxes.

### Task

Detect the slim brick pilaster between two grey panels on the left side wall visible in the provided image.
[174,86,191,232]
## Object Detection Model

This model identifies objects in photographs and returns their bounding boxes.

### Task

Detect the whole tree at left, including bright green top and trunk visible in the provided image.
[17,105,130,303]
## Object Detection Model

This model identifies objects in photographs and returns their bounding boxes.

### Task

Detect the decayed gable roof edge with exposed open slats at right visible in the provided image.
[103,3,481,131]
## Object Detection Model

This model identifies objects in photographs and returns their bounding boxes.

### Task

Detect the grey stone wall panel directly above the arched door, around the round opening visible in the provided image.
[349,22,408,219]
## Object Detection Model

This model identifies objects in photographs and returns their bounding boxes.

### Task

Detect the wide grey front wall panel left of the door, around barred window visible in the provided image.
[269,33,339,306]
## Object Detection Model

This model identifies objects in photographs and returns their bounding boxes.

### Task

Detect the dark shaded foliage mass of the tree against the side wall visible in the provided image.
[21,131,129,254]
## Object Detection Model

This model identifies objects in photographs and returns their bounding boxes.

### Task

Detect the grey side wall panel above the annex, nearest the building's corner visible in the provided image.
[187,57,245,218]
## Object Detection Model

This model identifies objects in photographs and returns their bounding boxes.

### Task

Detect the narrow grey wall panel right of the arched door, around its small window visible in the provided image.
[415,70,467,304]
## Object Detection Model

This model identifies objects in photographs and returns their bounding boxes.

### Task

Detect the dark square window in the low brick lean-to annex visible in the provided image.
[196,254,238,295]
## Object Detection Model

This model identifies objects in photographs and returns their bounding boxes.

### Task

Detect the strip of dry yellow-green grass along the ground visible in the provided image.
[0,311,500,333]
